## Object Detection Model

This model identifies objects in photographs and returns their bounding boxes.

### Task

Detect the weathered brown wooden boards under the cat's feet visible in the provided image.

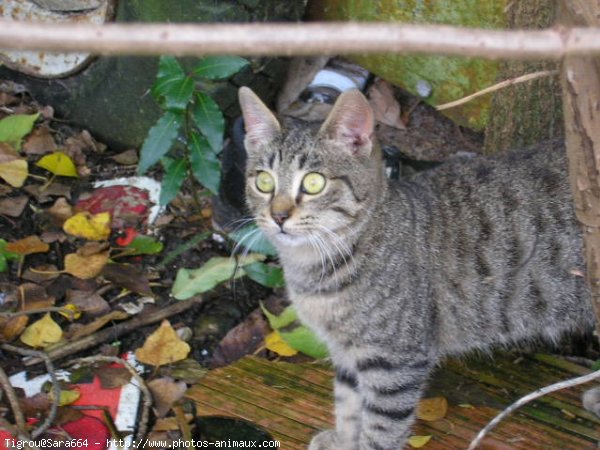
[187,354,600,450]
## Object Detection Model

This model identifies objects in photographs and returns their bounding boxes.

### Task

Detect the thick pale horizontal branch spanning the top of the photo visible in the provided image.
[0,20,600,60]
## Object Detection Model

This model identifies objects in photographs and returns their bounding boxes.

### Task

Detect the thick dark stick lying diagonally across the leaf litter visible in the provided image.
[25,296,202,366]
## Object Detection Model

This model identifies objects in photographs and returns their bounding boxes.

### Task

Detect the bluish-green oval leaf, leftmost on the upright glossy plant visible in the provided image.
[137,111,182,175]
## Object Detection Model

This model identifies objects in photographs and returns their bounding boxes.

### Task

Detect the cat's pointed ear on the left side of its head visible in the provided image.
[238,86,281,151]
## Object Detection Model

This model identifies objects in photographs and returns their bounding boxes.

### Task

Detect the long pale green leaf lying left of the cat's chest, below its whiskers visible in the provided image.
[171,253,264,300]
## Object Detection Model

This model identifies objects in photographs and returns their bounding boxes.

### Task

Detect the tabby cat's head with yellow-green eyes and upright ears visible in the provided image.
[239,87,385,249]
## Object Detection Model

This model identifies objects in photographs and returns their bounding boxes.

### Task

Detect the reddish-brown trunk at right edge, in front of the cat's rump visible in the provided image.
[561,0,600,336]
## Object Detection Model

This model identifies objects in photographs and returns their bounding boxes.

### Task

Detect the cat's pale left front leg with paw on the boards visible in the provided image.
[309,367,362,450]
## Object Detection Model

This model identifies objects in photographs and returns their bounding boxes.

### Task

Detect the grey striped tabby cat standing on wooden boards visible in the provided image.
[239,88,594,450]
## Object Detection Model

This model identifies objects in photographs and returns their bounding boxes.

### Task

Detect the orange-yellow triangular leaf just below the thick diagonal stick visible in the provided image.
[135,320,190,366]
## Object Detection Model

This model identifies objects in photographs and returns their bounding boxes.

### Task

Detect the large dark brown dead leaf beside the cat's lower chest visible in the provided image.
[210,309,270,368]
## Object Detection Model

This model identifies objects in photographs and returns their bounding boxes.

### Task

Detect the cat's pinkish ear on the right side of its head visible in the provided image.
[319,89,375,156]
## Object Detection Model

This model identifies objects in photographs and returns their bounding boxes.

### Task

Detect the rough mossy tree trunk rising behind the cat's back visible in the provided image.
[484,0,564,154]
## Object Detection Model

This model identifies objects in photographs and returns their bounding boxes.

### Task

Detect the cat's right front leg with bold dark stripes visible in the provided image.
[357,355,434,450]
